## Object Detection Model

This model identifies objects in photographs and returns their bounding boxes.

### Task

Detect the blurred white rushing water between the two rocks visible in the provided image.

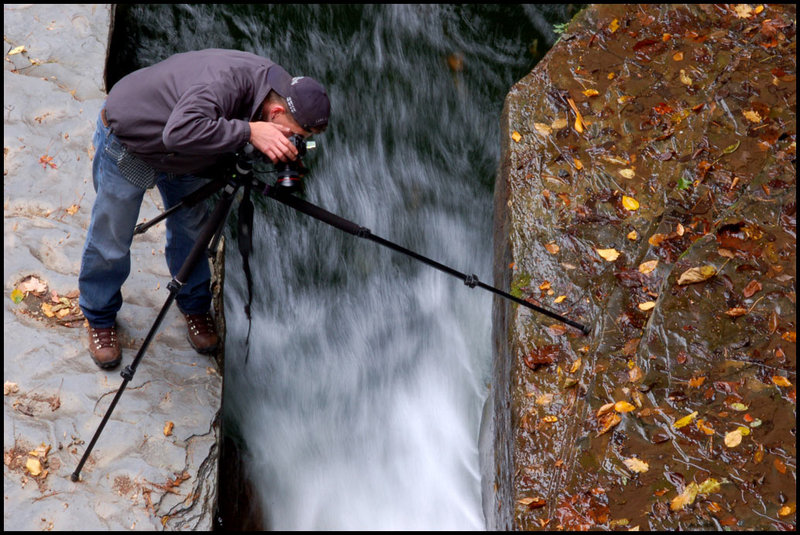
[110,5,571,530]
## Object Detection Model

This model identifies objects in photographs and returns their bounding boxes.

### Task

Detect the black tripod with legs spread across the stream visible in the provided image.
[71,143,590,481]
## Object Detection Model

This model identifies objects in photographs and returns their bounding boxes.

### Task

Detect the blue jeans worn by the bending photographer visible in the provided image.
[78,110,211,328]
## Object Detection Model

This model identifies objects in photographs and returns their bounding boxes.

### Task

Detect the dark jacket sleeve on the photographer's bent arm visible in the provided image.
[162,79,250,154]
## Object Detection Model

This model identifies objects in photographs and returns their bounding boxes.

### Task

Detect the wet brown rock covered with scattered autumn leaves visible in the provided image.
[490,5,797,530]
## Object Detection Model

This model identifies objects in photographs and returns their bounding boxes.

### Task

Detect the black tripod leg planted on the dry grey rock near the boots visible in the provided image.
[71,182,238,481]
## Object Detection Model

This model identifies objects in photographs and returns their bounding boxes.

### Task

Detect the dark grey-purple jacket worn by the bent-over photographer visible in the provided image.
[106,49,288,174]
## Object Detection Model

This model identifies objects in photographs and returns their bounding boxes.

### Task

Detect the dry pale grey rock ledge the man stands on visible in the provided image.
[3,4,222,531]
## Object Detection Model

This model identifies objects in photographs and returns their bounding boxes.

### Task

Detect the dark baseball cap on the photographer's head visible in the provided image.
[267,65,331,131]
